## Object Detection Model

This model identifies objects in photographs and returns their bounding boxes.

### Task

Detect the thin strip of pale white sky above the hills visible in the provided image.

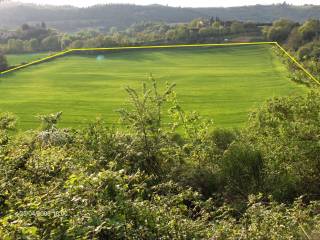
[16,0,320,7]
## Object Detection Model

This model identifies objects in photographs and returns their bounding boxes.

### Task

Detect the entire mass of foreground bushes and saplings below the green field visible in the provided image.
[0,81,320,239]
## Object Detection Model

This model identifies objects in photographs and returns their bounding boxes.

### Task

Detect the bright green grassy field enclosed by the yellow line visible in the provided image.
[0,45,306,129]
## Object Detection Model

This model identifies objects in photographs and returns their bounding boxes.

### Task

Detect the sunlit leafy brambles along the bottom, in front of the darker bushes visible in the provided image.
[0,127,320,239]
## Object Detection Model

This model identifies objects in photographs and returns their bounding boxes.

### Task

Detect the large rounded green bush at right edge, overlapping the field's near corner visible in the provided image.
[240,91,320,200]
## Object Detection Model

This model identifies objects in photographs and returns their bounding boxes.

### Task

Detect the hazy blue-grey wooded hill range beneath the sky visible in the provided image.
[0,3,320,31]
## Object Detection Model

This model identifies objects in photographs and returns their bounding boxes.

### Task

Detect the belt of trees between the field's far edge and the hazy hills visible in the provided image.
[0,18,262,54]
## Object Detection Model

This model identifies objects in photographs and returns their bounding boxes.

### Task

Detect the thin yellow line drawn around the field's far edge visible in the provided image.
[0,42,320,85]
